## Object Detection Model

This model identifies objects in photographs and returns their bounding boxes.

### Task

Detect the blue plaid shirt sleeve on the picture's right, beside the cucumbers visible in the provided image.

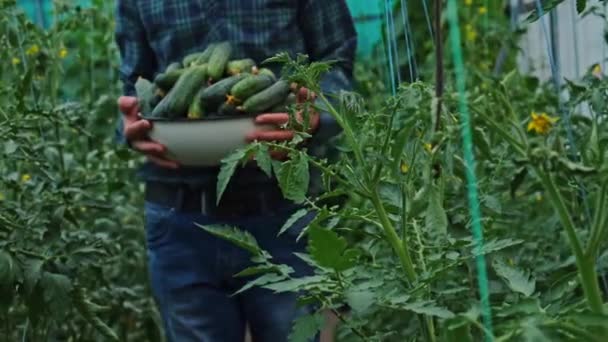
[299,0,357,147]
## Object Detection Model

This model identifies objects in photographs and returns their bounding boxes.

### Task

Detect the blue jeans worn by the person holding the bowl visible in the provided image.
[145,202,312,342]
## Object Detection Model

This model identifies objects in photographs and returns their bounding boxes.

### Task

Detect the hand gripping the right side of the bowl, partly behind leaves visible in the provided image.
[247,88,320,159]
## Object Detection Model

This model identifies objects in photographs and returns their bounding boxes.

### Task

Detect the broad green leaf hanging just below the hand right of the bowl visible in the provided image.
[274,153,310,203]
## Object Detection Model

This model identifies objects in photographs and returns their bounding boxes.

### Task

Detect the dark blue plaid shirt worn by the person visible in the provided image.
[116,0,357,185]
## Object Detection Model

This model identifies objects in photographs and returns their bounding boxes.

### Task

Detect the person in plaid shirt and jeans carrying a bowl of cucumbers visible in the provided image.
[116,0,356,342]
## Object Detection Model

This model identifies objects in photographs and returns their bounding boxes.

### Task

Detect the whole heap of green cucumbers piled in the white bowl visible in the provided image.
[135,42,295,119]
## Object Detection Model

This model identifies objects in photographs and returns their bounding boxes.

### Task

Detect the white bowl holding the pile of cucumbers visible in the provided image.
[145,116,271,166]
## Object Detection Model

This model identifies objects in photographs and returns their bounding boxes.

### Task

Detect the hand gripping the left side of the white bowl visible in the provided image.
[118,96,179,169]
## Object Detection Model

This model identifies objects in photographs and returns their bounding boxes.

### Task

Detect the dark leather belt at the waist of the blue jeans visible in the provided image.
[145,182,289,218]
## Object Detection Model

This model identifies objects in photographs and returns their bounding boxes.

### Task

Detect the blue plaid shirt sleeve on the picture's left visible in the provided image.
[115,0,157,143]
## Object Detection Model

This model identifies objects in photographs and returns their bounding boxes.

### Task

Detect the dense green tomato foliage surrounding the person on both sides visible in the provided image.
[0,0,608,341]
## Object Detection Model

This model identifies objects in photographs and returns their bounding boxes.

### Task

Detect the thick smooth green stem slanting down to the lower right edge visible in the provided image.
[534,166,604,314]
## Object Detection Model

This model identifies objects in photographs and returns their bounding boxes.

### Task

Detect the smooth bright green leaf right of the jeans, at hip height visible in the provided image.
[308,226,357,272]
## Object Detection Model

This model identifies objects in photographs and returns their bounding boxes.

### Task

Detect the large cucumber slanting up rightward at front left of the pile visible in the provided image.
[152,65,207,119]
